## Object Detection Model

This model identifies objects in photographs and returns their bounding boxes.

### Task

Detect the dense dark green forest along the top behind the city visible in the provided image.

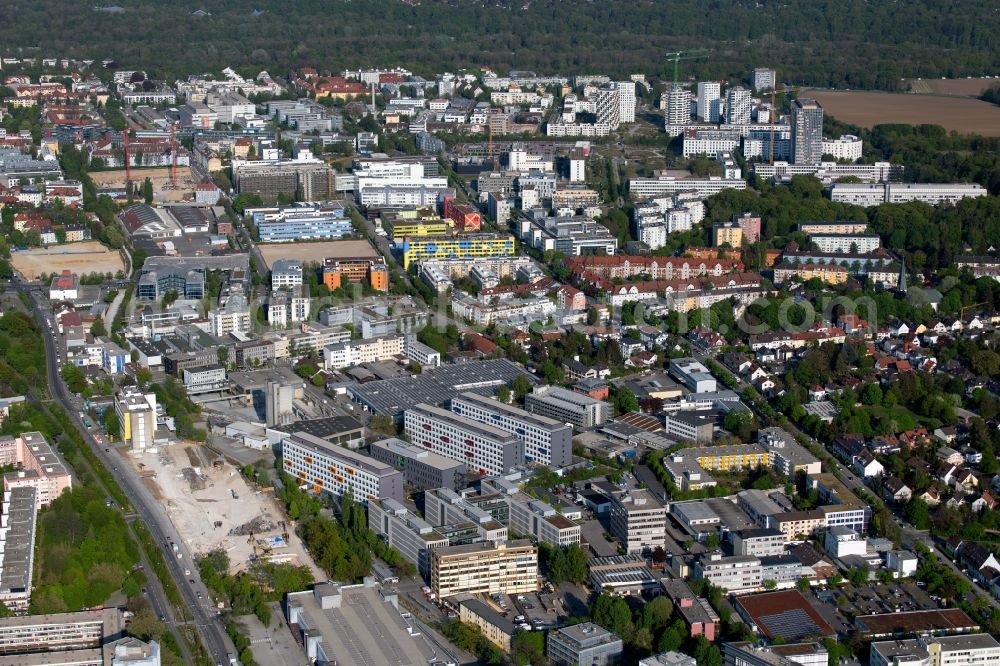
[0,0,1000,89]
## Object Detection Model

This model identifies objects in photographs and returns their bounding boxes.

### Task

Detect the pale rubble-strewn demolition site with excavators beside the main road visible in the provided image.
[123,443,323,580]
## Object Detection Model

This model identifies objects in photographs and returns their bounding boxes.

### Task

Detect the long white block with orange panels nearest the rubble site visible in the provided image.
[281,432,403,503]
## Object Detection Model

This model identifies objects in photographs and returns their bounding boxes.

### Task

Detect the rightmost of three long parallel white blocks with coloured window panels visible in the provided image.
[452,392,573,464]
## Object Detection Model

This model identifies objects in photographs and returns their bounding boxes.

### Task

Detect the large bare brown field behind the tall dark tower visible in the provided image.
[800,90,1000,136]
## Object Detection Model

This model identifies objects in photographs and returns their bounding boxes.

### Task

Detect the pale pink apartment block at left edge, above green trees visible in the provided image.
[0,432,73,509]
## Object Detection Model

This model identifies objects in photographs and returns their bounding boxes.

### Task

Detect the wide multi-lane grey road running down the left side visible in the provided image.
[14,282,236,666]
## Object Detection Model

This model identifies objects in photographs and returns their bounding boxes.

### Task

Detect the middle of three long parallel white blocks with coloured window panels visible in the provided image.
[404,404,524,475]
